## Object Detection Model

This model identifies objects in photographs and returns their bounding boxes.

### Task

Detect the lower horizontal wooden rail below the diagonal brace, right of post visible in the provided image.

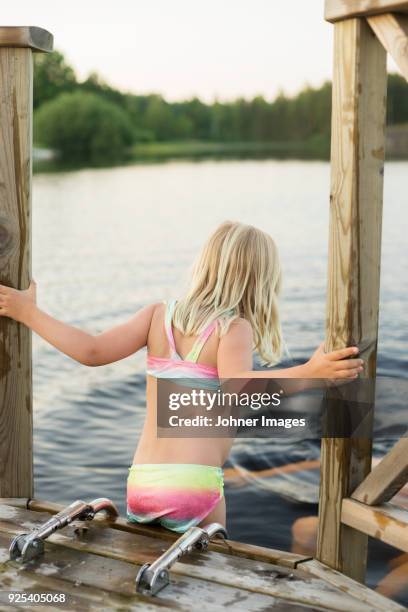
[341,499,408,552]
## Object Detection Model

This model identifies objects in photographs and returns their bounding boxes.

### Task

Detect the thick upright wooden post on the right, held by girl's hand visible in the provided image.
[317,18,386,581]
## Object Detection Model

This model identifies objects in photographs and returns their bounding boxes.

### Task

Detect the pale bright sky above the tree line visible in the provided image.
[1,0,396,102]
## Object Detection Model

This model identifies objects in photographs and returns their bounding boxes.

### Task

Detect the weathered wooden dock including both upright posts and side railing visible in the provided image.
[0,0,408,612]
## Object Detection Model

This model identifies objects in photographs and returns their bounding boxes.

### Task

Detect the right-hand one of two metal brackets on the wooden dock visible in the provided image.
[136,523,228,595]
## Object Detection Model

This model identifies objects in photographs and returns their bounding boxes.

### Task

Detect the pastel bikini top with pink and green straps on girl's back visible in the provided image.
[147,300,218,384]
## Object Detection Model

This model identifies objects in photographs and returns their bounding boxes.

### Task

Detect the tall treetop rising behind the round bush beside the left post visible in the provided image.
[33,51,78,108]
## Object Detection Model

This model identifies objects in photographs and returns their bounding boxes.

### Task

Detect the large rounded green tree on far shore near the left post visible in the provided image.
[34,91,133,164]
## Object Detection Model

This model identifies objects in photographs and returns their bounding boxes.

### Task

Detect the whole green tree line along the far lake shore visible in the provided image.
[34,52,408,163]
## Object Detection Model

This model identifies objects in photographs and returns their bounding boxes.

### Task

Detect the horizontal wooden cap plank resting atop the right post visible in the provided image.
[324,0,408,22]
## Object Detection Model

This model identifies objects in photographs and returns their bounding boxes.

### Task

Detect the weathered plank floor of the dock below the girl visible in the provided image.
[0,499,405,612]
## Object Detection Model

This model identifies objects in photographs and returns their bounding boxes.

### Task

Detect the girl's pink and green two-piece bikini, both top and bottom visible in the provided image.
[127,301,224,533]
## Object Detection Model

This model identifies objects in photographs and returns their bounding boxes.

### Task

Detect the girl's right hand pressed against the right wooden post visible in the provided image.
[305,343,364,380]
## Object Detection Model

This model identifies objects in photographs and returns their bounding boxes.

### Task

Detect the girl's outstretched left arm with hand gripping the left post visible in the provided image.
[0,281,156,366]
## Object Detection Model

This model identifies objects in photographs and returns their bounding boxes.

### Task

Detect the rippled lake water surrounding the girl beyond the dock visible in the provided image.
[33,160,408,601]
